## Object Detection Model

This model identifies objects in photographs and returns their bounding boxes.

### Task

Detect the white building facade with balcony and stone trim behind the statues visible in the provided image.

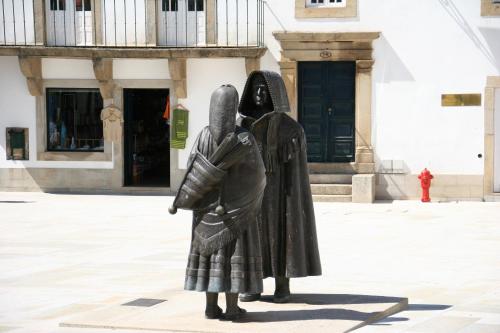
[0,0,500,202]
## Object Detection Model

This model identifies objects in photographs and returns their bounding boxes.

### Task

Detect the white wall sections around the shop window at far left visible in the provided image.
[0,56,113,169]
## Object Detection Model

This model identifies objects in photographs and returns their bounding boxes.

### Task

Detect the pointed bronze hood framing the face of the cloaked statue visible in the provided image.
[238,71,290,118]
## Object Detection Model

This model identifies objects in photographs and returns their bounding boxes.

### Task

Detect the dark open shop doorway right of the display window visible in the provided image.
[123,89,170,187]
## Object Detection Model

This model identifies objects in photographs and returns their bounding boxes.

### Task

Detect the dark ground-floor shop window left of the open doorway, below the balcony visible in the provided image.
[47,88,104,151]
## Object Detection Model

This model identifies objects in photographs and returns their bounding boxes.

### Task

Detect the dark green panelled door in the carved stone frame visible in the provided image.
[298,61,356,162]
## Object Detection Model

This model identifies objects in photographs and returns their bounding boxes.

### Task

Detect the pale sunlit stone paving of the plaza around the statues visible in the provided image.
[0,193,500,333]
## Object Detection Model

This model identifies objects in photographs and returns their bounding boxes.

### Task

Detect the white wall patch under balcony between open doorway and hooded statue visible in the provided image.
[179,58,246,169]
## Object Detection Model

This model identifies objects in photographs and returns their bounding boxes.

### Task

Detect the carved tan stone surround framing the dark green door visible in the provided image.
[273,31,380,173]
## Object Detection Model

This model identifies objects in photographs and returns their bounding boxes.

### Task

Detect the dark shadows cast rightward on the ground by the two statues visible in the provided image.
[238,294,450,325]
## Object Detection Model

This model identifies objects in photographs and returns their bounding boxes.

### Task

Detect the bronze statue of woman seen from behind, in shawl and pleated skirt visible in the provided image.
[169,85,266,320]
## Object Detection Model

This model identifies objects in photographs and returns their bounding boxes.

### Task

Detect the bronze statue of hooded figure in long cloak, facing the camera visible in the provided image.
[237,71,321,303]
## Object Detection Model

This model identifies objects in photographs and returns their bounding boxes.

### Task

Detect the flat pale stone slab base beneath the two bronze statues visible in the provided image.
[60,291,408,333]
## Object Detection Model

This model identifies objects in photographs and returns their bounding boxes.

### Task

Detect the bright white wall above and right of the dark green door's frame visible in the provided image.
[265,0,500,174]
